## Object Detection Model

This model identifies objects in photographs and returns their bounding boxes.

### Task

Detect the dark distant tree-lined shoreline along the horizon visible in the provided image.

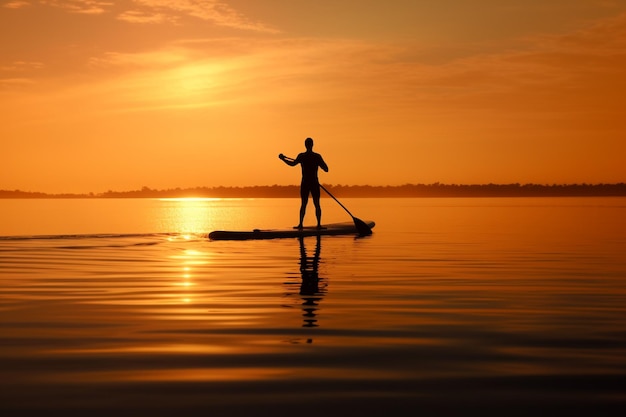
[0,183,626,199]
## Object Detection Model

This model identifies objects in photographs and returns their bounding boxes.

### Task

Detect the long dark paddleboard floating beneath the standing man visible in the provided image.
[209,220,376,240]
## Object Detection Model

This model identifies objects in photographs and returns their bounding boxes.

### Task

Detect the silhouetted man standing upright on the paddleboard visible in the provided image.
[278,138,328,229]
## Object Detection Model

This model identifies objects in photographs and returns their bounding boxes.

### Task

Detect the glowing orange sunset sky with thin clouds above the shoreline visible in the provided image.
[0,0,626,192]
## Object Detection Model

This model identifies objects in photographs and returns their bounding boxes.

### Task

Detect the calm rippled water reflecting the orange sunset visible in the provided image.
[0,198,626,416]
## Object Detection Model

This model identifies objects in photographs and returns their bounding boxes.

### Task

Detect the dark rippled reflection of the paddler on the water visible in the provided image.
[299,236,324,327]
